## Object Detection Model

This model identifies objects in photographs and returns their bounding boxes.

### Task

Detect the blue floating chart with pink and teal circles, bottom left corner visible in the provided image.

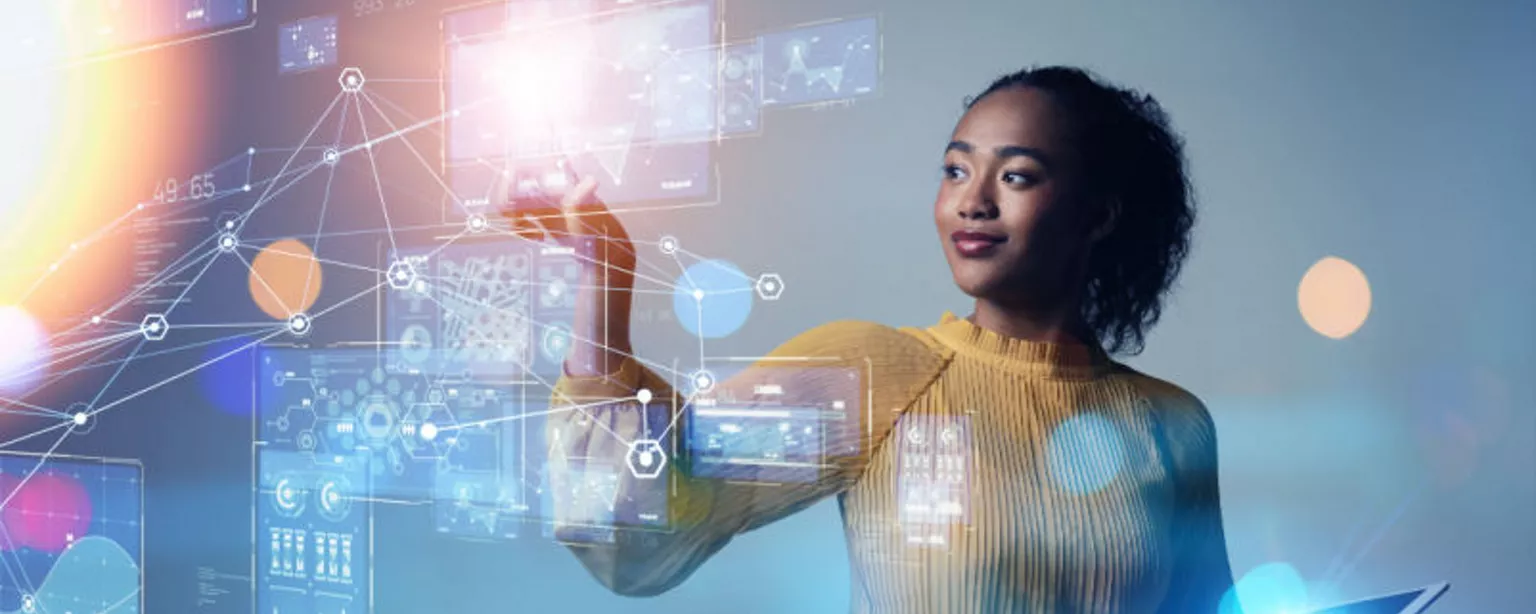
[0,453,143,614]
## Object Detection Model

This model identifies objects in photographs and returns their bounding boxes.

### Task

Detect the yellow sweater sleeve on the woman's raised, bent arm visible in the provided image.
[548,321,946,596]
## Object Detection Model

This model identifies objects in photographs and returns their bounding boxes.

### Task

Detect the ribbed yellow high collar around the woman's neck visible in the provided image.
[928,312,1111,379]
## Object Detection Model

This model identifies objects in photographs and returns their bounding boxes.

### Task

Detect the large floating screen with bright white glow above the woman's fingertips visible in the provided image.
[444,0,719,209]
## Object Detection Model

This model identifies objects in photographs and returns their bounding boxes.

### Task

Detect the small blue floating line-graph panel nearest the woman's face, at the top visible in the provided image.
[759,17,880,104]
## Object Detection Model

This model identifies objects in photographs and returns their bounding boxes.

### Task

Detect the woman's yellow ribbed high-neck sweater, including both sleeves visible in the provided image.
[550,312,1232,612]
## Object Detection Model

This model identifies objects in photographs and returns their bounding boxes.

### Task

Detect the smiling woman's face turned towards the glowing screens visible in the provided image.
[934,87,1087,309]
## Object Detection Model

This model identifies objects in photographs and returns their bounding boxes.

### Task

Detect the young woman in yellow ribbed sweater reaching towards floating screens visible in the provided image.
[516,66,1232,612]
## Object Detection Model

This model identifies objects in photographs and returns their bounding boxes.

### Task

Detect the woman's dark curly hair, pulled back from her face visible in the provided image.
[965,66,1195,355]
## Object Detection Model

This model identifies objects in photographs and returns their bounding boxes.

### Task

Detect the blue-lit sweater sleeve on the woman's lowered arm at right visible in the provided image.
[1155,388,1241,614]
